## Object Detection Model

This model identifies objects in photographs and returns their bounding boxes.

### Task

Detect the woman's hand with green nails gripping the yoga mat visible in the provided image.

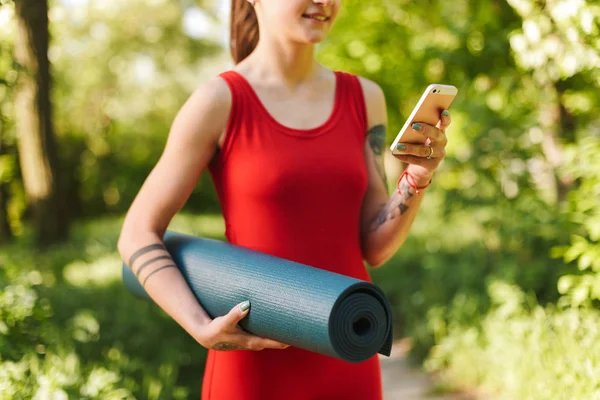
[196,302,289,351]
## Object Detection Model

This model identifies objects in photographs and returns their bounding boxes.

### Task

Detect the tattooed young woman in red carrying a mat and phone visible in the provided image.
[119,0,450,400]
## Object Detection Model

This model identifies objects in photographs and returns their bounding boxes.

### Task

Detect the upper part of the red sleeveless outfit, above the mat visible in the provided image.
[209,71,368,279]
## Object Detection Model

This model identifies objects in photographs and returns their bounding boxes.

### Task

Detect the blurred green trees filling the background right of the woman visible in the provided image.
[319,0,600,355]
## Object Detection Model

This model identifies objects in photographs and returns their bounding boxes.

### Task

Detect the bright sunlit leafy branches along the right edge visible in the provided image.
[509,0,600,307]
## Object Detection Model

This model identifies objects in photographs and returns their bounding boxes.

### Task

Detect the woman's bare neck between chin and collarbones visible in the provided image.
[244,35,322,88]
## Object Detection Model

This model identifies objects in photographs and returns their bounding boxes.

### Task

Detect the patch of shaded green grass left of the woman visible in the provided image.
[0,215,224,400]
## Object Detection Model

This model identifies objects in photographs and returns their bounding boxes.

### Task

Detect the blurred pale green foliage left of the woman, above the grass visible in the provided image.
[0,0,226,222]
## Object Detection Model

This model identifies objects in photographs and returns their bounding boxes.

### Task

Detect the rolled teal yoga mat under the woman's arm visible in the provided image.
[123,231,392,362]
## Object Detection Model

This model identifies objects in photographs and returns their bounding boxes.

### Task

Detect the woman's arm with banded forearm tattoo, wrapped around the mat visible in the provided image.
[118,78,286,350]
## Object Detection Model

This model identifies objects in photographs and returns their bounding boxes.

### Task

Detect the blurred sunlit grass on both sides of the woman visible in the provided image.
[0,208,600,400]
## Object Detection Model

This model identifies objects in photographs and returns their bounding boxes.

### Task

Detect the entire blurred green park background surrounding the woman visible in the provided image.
[0,0,600,399]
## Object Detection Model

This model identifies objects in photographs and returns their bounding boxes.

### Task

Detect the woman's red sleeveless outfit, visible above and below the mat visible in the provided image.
[202,71,381,400]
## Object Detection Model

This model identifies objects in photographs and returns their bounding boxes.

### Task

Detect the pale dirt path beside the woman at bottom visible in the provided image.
[379,341,481,400]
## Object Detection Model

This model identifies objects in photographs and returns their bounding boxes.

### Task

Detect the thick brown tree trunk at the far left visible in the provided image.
[15,0,68,245]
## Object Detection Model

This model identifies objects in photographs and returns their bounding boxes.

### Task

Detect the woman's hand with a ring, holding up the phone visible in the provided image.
[395,110,452,186]
